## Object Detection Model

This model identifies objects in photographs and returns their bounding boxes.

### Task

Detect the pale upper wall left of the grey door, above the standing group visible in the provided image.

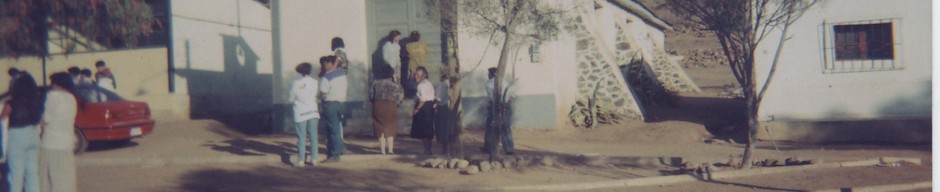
[272,0,370,103]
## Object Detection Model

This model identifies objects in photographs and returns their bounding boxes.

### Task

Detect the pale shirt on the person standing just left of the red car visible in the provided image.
[42,89,78,150]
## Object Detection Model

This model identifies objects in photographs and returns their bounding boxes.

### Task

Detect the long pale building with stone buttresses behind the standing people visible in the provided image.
[0,0,697,132]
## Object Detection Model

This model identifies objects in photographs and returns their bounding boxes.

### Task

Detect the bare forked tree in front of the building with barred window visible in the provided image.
[665,0,821,168]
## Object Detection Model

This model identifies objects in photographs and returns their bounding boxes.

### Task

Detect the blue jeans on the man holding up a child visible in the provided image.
[323,101,346,157]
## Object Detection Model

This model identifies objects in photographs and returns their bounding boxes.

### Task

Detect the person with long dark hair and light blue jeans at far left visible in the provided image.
[0,73,43,192]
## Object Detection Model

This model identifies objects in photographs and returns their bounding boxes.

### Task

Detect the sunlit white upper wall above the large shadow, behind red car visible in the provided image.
[171,0,272,76]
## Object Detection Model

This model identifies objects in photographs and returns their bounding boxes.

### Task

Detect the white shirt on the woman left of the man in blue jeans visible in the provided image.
[290,75,320,123]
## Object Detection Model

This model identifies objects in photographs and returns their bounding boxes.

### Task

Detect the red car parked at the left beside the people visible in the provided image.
[75,85,156,154]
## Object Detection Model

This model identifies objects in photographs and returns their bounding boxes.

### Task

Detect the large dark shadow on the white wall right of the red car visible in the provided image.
[176,35,273,134]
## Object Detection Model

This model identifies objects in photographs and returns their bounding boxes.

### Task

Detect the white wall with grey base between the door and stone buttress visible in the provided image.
[458,1,578,129]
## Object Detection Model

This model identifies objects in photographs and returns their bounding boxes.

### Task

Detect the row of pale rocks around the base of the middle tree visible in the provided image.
[418,156,557,175]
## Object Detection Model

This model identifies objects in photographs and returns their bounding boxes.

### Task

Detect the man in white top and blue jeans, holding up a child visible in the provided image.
[320,56,347,163]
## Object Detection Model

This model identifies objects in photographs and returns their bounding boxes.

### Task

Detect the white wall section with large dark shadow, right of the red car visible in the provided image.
[170,0,274,121]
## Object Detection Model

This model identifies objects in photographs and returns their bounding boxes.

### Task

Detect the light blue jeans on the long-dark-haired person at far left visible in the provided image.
[7,125,40,192]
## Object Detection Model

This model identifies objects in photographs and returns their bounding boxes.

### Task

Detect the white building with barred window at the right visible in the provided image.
[756,0,933,142]
